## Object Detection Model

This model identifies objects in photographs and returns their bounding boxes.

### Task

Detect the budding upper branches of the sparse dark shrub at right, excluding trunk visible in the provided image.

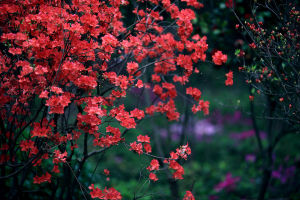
[235,1,300,125]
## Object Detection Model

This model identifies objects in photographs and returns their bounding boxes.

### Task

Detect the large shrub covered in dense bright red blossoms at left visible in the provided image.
[0,0,226,199]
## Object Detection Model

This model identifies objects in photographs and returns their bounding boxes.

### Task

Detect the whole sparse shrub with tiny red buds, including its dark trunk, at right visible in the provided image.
[231,0,300,200]
